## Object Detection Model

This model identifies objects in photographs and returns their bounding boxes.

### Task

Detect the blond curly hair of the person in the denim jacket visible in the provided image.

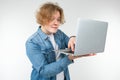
[36,2,65,26]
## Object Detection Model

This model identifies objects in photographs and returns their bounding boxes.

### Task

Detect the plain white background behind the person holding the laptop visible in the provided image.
[0,0,120,80]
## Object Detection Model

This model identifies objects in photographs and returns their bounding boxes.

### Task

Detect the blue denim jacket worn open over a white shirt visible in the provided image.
[26,27,72,80]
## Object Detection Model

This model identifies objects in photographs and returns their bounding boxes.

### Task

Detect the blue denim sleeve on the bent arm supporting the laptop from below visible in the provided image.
[26,41,72,77]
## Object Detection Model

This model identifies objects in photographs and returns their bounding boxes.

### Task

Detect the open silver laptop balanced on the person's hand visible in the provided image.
[54,19,108,56]
